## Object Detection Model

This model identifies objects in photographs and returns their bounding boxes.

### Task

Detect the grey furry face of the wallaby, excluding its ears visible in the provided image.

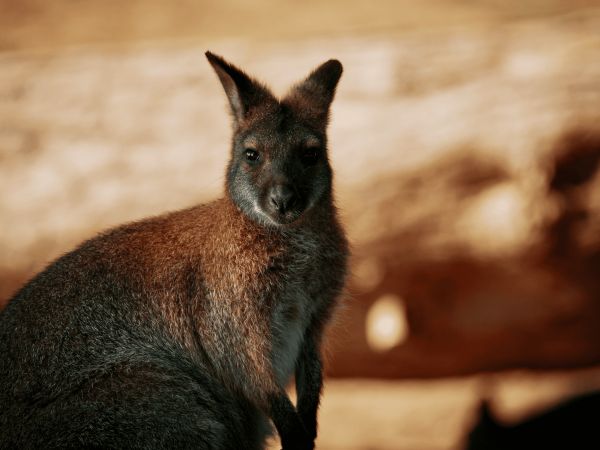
[227,105,331,226]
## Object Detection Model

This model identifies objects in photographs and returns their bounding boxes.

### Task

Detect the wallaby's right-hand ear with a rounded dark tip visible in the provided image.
[284,59,343,123]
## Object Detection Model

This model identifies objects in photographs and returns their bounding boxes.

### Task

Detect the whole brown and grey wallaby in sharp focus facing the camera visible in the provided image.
[0,52,348,449]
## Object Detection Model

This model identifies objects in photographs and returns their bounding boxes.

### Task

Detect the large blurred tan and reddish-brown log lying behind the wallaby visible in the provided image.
[0,8,600,377]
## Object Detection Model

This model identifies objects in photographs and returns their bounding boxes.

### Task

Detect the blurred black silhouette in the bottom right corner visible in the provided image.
[466,392,600,450]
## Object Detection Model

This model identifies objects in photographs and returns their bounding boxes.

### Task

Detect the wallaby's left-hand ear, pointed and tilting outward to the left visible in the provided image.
[205,52,273,125]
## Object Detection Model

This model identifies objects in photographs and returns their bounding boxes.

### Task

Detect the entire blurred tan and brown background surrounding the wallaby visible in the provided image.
[0,0,600,450]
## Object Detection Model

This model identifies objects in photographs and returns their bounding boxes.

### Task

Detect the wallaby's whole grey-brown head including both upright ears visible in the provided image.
[206,52,342,227]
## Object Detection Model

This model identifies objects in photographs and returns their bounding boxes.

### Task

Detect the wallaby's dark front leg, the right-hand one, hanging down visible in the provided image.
[296,329,323,441]
